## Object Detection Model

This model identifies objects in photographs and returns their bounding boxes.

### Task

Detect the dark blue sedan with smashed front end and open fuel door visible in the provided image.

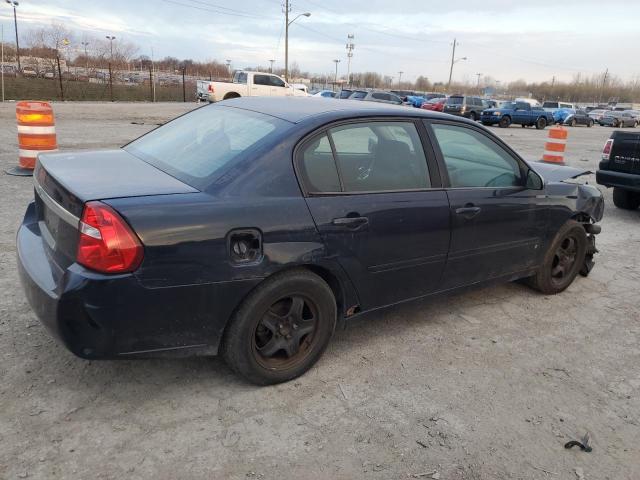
[17,98,603,384]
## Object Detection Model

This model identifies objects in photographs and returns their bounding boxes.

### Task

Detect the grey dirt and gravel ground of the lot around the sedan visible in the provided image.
[0,103,640,480]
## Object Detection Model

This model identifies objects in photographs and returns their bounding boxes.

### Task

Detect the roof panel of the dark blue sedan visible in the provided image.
[217,97,453,123]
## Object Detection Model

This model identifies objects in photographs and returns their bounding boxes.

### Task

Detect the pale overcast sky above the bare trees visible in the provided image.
[0,0,640,82]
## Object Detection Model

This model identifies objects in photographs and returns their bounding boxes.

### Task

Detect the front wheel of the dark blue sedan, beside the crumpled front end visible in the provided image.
[529,220,588,295]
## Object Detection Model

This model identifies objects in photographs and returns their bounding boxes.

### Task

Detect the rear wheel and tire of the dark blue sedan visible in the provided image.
[221,269,337,385]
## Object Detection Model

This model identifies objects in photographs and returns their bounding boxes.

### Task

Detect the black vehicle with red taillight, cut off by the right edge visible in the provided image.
[596,130,640,210]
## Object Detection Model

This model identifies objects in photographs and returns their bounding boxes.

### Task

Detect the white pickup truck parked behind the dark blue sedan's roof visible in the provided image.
[196,70,308,102]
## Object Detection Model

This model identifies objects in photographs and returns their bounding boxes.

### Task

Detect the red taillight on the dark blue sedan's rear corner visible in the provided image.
[76,202,143,273]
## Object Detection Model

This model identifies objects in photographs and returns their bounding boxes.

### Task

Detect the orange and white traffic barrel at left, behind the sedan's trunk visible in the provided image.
[7,101,58,176]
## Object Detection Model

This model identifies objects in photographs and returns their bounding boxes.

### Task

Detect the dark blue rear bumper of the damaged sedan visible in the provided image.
[17,204,259,359]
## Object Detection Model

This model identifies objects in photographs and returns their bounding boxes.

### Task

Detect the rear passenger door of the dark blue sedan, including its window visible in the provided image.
[296,119,450,309]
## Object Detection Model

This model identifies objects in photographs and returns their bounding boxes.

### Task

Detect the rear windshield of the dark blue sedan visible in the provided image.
[124,105,289,190]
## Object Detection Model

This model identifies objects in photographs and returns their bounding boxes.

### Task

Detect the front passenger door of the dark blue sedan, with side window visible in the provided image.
[429,121,546,289]
